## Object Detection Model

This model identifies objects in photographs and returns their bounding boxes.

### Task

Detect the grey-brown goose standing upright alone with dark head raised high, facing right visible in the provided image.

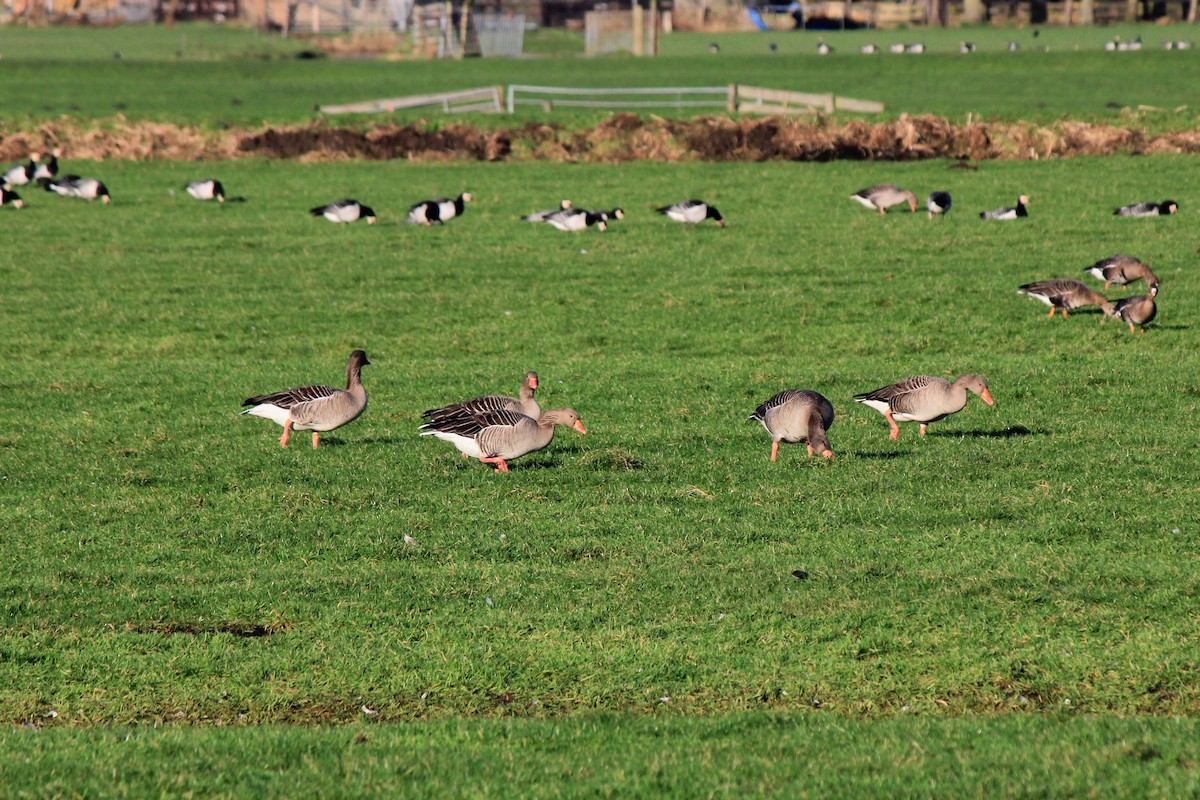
[235,350,371,450]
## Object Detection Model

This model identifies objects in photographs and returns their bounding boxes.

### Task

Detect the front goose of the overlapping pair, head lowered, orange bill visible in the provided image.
[421,408,588,473]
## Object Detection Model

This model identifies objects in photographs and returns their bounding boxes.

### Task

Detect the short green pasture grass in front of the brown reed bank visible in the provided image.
[0,151,1200,796]
